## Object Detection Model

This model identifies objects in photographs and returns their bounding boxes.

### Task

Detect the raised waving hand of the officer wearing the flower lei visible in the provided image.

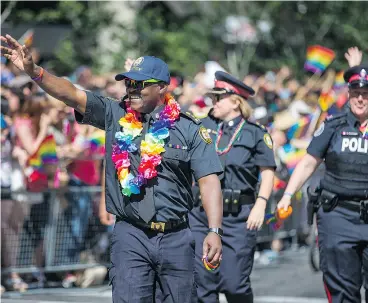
[0,35,35,77]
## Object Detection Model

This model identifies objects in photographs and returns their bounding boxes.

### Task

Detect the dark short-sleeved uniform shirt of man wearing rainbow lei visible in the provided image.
[75,92,222,222]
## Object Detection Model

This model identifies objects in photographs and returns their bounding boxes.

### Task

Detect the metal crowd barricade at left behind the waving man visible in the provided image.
[2,186,109,274]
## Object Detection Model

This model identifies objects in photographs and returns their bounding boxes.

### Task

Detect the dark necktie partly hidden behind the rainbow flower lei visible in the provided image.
[139,114,156,223]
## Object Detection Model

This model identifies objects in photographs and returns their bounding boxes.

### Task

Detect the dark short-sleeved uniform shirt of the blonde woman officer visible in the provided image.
[202,115,276,193]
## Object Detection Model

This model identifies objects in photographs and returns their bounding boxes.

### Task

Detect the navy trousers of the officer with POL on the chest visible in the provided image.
[317,206,368,303]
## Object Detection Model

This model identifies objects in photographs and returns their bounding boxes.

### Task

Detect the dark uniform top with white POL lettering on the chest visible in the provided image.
[307,110,368,197]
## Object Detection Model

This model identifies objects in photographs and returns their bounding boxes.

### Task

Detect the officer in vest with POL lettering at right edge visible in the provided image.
[278,66,368,303]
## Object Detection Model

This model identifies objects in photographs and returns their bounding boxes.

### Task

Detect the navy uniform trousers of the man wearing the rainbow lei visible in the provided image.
[109,221,197,303]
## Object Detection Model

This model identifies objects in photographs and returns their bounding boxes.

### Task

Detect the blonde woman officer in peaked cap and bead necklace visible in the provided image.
[189,71,276,303]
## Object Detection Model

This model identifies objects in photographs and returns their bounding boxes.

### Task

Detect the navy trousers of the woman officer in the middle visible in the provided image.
[189,205,257,303]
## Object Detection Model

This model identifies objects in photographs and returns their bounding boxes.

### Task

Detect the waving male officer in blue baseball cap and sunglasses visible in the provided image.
[1,35,222,303]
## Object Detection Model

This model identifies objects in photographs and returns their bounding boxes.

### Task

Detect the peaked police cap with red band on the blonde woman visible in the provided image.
[208,71,255,99]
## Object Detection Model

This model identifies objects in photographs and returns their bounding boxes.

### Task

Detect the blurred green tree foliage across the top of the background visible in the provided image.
[4,1,368,77]
